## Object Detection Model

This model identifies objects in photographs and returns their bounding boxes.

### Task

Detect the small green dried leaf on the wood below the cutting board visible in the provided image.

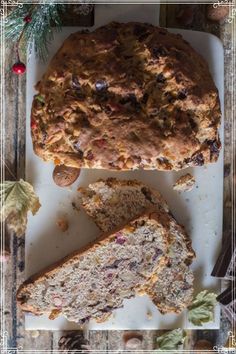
[156,328,186,351]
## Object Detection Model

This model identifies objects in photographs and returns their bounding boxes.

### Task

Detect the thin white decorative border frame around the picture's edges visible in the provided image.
[0,0,236,354]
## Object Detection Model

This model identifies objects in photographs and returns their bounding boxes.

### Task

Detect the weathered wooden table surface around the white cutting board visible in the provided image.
[4,4,236,353]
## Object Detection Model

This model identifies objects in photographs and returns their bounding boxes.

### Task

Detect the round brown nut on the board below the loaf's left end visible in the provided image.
[53,165,80,187]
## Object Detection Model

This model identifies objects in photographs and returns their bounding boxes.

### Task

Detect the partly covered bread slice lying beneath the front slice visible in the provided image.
[79,178,195,314]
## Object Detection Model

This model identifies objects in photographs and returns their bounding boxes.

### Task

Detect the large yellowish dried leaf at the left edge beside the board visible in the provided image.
[0,179,41,236]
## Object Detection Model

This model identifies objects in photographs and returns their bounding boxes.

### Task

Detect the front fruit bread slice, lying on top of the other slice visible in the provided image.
[17,210,169,322]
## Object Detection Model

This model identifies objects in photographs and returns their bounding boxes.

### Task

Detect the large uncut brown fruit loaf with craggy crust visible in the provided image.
[31,22,221,170]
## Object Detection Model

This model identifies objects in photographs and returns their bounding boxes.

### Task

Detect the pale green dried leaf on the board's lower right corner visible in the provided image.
[188,290,217,326]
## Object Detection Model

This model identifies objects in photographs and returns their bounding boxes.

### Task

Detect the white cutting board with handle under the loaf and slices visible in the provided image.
[25,5,224,330]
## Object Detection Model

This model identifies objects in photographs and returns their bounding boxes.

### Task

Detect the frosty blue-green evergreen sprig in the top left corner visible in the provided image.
[5,1,65,60]
